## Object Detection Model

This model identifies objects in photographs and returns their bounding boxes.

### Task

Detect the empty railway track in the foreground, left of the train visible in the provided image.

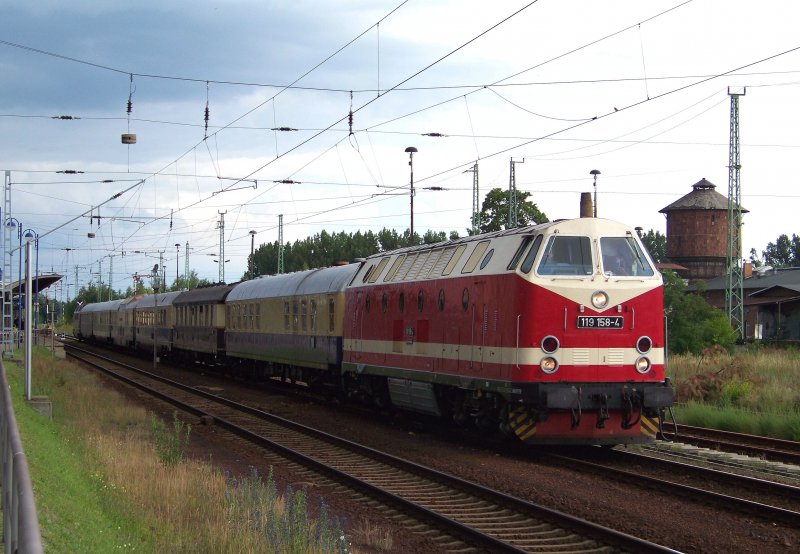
[67,345,674,553]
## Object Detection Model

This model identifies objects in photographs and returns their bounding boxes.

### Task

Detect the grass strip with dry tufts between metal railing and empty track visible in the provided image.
[5,349,391,554]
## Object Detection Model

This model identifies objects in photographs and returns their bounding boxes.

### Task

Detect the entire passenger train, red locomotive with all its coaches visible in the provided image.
[73,217,673,445]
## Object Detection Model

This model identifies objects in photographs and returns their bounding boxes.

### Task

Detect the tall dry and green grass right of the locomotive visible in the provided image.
[667,346,800,440]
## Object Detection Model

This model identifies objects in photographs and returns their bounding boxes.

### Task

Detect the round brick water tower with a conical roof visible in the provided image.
[659,178,748,281]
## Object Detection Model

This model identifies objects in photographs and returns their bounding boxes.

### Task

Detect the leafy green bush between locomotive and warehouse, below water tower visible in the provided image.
[662,270,737,354]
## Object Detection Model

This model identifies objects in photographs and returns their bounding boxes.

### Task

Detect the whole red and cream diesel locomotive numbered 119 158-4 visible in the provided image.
[342,218,672,444]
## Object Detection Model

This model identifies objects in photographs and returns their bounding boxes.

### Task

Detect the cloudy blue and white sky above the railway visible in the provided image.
[0,0,800,296]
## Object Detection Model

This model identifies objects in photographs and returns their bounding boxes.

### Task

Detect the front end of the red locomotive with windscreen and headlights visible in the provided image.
[508,218,673,444]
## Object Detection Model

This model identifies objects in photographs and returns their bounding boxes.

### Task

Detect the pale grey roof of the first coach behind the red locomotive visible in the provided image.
[226,264,361,302]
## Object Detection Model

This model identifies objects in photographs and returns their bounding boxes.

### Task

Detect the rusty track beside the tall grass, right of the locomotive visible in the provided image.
[663,423,800,465]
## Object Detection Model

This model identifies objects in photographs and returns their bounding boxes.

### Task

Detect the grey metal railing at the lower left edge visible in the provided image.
[0,361,44,554]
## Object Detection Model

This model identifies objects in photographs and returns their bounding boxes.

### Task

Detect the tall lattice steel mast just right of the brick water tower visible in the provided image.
[725,88,746,340]
